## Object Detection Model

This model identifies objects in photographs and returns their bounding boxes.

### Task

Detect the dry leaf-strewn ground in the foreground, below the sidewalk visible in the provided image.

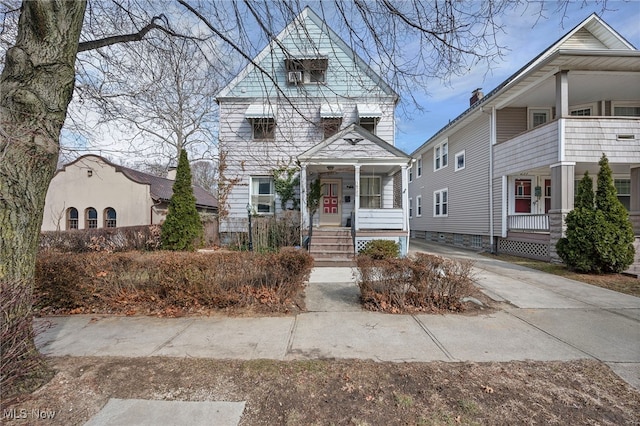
[2,357,640,426]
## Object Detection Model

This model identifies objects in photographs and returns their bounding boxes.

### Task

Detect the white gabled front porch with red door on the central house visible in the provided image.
[298,125,411,255]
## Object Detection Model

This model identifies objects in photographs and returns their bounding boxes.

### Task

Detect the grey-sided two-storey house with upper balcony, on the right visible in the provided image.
[409,15,640,260]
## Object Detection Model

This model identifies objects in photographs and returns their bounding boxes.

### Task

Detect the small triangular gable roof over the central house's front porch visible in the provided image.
[298,124,411,164]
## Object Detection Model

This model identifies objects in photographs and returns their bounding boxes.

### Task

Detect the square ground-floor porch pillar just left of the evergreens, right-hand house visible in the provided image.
[548,161,576,263]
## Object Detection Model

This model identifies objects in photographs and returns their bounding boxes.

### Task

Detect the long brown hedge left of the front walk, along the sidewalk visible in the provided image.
[36,248,313,314]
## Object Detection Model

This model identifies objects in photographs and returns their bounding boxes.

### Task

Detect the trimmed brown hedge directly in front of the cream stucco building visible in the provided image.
[40,225,161,253]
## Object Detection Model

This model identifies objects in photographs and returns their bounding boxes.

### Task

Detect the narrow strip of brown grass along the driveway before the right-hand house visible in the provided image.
[488,254,640,297]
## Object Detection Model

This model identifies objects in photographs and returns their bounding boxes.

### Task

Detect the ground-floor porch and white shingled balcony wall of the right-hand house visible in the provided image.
[494,117,640,261]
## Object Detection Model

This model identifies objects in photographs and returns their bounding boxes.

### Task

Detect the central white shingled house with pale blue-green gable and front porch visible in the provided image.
[217,7,411,261]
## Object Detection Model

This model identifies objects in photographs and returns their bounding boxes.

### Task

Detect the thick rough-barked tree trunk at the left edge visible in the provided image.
[0,0,86,392]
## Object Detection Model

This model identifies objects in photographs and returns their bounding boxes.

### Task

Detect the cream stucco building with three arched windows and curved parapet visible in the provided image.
[42,155,218,231]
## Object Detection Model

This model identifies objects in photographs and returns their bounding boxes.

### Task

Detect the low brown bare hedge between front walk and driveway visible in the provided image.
[357,253,474,313]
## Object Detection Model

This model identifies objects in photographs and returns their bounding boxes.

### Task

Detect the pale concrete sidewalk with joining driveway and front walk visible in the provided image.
[38,241,640,425]
